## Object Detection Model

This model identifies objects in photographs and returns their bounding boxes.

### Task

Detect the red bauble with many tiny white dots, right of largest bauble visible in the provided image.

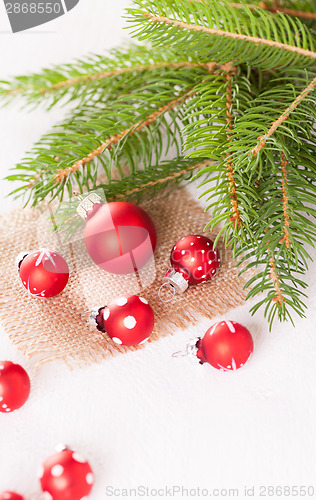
[163,234,220,293]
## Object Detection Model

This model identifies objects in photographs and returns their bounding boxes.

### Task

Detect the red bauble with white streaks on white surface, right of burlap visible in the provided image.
[196,321,253,371]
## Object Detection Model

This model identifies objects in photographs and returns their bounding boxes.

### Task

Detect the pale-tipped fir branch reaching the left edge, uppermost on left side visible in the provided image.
[0,45,208,108]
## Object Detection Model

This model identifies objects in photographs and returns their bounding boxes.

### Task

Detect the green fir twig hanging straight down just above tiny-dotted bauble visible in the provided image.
[182,72,257,251]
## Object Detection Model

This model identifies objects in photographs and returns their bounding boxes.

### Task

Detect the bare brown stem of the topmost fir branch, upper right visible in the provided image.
[143,13,316,59]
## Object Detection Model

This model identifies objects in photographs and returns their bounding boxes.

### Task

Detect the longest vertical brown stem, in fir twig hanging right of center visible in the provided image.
[226,72,242,227]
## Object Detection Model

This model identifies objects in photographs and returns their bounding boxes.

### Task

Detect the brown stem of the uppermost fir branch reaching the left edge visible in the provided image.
[5,61,215,95]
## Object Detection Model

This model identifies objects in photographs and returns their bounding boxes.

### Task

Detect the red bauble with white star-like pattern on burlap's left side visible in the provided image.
[17,248,69,298]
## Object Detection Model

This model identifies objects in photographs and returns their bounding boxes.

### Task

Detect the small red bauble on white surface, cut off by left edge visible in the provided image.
[0,361,31,413]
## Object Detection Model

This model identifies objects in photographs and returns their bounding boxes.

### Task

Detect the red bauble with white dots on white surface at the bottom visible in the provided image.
[39,448,94,500]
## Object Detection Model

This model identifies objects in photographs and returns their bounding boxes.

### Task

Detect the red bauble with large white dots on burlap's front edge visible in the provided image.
[90,295,155,346]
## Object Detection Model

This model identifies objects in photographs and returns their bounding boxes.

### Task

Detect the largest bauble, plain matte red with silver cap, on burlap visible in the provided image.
[77,193,156,274]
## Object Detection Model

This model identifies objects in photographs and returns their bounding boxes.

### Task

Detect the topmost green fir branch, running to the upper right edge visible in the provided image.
[129,0,316,69]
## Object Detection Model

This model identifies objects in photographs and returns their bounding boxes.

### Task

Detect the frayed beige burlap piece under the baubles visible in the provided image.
[0,189,251,365]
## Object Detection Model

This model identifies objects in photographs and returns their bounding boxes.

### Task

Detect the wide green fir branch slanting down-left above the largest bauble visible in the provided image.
[8,63,225,204]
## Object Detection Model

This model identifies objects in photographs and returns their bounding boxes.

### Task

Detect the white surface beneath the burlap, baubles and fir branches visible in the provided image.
[0,0,316,500]
